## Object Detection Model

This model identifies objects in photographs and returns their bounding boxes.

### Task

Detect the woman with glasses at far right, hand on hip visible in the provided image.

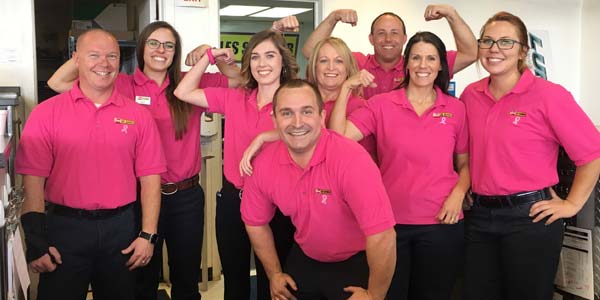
[461,12,600,300]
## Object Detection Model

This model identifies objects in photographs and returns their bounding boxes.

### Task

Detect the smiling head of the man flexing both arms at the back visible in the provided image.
[369,15,406,63]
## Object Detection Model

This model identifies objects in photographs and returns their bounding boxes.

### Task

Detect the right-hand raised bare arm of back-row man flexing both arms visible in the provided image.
[425,4,477,74]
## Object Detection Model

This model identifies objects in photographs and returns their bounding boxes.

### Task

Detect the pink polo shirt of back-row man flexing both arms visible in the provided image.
[352,51,457,99]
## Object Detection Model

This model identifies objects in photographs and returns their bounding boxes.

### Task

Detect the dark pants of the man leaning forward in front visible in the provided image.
[285,243,369,300]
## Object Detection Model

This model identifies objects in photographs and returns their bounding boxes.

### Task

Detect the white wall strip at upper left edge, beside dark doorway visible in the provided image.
[0,0,37,117]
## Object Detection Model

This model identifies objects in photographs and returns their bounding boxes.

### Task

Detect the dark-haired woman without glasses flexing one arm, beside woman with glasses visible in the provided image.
[329,32,469,300]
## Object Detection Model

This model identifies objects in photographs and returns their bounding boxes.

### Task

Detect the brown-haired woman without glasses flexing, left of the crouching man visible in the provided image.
[175,30,298,300]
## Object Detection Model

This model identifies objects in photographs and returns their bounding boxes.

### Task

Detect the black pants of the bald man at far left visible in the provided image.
[38,203,137,300]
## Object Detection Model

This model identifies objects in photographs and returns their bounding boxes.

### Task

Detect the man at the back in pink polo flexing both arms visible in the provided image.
[302,4,477,99]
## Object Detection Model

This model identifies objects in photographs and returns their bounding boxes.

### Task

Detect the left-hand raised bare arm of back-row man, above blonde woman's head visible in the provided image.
[302,9,358,59]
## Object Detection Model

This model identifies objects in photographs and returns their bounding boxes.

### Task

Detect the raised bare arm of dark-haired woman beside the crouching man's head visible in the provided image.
[329,70,377,141]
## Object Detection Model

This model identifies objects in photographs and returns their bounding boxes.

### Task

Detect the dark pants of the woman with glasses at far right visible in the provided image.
[464,204,564,300]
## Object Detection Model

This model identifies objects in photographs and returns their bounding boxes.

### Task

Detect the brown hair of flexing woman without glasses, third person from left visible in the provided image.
[241,29,298,89]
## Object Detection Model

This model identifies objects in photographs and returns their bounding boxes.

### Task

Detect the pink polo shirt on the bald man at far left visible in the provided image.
[16,82,166,210]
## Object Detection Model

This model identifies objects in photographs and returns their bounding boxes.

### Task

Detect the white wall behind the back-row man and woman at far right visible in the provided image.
[323,0,580,103]
